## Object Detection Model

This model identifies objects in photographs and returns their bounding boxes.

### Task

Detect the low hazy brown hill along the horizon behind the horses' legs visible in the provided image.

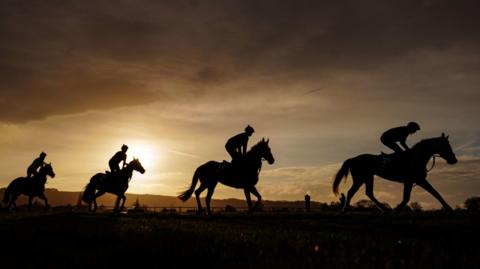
[0,188,323,208]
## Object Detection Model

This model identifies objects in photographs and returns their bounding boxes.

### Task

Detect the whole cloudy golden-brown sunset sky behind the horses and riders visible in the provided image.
[0,0,480,208]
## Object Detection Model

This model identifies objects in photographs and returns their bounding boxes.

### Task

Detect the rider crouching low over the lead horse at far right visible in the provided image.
[380,122,420,153]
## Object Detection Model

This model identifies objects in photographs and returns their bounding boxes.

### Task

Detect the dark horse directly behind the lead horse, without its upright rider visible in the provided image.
[178,139,275,214]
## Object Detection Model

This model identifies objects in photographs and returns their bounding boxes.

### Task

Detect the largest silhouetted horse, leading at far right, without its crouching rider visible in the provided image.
[333,133,457,211]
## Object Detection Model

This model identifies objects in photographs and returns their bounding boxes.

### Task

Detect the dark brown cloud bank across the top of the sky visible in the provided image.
[0,0,480,122]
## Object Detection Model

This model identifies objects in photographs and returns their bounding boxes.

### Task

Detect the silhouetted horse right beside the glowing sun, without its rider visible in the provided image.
[82,159,145,212]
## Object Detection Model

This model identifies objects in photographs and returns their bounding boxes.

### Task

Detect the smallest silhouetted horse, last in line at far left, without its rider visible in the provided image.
[3,164,55,210]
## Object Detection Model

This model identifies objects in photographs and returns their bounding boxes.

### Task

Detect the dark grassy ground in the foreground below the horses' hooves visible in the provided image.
[0,212,480,268]
